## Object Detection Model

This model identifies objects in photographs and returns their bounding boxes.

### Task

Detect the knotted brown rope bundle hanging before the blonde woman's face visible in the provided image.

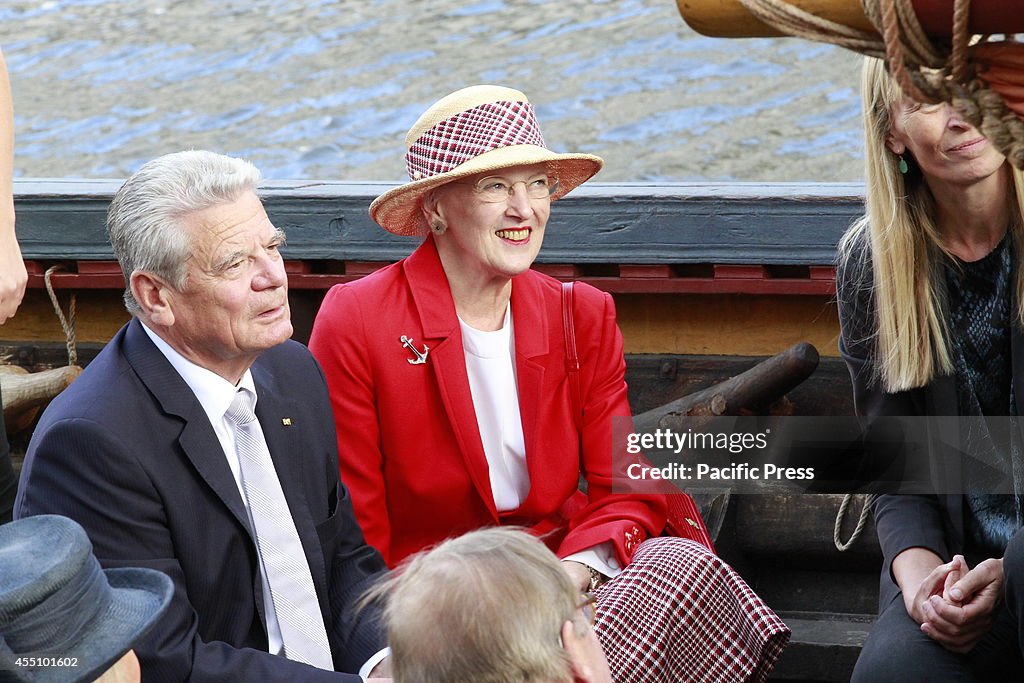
[739,0,1024,169]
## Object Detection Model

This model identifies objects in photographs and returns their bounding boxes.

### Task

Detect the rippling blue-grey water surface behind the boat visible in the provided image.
[0,0,861,181]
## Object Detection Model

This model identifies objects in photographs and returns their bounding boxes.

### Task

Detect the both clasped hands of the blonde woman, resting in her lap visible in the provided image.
[904,555,1002,653]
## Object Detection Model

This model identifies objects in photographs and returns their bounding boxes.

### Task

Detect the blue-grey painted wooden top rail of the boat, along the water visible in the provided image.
[14,179,862,265]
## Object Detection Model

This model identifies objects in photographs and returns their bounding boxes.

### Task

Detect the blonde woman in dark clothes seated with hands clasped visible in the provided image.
[837,59,1024,681]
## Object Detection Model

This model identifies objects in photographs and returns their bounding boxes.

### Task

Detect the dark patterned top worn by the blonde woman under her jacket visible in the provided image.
[945,232,1022,561]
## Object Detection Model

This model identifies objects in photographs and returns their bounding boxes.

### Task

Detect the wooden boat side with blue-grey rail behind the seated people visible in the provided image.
[0,180,880,681]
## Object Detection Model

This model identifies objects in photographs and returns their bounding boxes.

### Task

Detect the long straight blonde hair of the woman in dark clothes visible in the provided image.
[839,57,1024,392]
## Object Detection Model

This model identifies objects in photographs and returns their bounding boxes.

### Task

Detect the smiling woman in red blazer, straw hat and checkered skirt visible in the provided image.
[309,86,788,682]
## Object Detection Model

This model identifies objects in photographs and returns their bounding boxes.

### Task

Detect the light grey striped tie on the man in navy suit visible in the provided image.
[224,389,334,671]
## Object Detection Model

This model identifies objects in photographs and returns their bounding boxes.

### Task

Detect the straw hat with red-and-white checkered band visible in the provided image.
[370,85,604,234]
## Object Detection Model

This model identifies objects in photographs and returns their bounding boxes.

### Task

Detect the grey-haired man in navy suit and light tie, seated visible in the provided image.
[15,152,386,681]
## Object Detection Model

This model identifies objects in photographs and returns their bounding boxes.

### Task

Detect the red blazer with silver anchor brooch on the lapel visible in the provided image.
[309,238,666,566]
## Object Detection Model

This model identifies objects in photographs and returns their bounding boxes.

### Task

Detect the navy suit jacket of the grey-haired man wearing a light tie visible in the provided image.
[15,319,384,681]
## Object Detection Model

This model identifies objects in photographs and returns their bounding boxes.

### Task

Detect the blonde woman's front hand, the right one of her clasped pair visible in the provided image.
[921,555,1002,653]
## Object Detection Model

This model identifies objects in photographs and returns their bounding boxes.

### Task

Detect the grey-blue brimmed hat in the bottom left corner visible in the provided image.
[0,515,174,682]
